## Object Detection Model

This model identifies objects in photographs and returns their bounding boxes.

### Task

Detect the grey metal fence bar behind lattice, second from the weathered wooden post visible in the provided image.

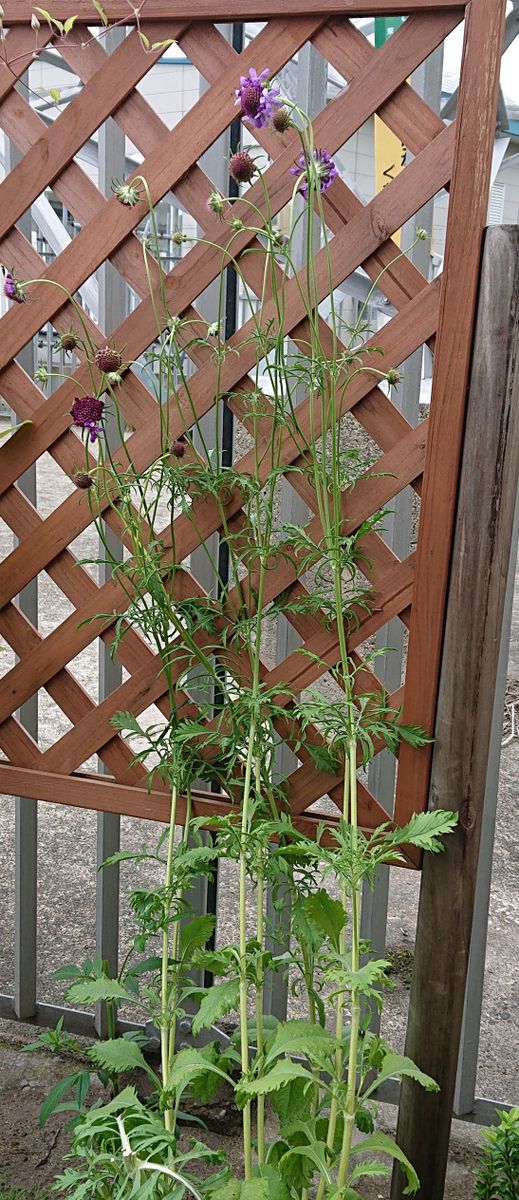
[264,43,328,1020]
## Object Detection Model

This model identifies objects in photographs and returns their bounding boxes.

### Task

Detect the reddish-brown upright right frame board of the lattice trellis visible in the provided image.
[396,0,505,822]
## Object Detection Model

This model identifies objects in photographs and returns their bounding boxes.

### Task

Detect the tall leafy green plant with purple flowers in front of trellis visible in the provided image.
[19,72,455,1200]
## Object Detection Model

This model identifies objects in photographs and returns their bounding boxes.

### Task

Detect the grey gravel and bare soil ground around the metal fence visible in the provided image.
[0,424,519,1200]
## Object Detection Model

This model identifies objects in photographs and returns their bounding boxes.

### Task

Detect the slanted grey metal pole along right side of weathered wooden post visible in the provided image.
[453,477,519,1117]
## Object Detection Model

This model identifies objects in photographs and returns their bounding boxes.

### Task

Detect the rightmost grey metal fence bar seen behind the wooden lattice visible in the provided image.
[360,47,443,1031]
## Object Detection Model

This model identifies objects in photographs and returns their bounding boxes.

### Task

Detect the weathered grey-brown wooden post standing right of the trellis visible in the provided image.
[390,226,519,1200]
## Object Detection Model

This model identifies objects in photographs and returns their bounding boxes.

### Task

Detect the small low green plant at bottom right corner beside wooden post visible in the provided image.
[475,1108,519,1200]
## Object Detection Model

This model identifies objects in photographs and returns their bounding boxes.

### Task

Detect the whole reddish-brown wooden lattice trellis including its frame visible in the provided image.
[0,0,505,865]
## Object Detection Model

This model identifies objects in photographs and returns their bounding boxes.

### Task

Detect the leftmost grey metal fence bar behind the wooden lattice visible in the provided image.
[5,129,38,1020]
